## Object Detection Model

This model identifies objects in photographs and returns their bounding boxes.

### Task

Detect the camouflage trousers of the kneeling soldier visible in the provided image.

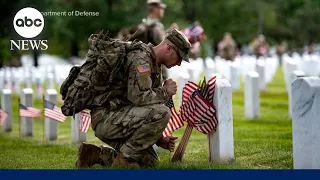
[92,104,171,166]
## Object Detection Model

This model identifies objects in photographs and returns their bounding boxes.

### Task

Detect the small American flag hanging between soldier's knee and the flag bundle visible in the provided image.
[162,98,184,137]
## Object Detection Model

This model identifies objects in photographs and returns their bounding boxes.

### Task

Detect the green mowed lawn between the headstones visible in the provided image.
[0,68,293,169]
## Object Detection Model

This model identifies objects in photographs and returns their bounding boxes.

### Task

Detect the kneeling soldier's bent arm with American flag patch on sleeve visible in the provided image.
[127,52,169,106]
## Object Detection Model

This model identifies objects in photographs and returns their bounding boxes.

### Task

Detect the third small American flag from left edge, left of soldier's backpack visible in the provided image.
[44,100,66,122]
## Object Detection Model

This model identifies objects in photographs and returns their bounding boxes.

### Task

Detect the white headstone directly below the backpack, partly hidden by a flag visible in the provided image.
[71,113,87,144]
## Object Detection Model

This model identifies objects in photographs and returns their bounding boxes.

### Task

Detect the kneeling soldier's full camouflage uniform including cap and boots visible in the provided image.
[77,30,191,167]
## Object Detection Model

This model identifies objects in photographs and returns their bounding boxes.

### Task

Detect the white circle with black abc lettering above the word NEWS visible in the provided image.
[13,7,44,38]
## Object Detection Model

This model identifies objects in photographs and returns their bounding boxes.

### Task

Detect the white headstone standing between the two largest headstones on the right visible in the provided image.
[244,71,260,119]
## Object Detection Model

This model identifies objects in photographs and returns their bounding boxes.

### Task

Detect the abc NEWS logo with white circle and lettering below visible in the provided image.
[10,7,48,50]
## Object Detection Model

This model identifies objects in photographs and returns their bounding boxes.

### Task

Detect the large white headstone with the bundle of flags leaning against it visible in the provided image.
[208,79,234,162]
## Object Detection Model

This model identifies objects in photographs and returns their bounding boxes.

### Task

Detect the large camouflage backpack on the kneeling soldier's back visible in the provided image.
[60,31,142,116]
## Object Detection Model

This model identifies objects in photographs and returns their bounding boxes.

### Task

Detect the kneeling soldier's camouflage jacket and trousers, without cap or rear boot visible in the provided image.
[91,41,171,164]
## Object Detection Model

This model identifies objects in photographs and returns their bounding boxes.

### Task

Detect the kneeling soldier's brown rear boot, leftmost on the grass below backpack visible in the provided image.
[76,143,117,168]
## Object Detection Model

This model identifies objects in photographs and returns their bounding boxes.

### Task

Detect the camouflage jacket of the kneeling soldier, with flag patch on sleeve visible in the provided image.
[92,42,169,110]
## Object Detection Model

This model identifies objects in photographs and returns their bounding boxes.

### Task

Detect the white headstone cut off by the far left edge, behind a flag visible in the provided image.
[1,89,12,132]
